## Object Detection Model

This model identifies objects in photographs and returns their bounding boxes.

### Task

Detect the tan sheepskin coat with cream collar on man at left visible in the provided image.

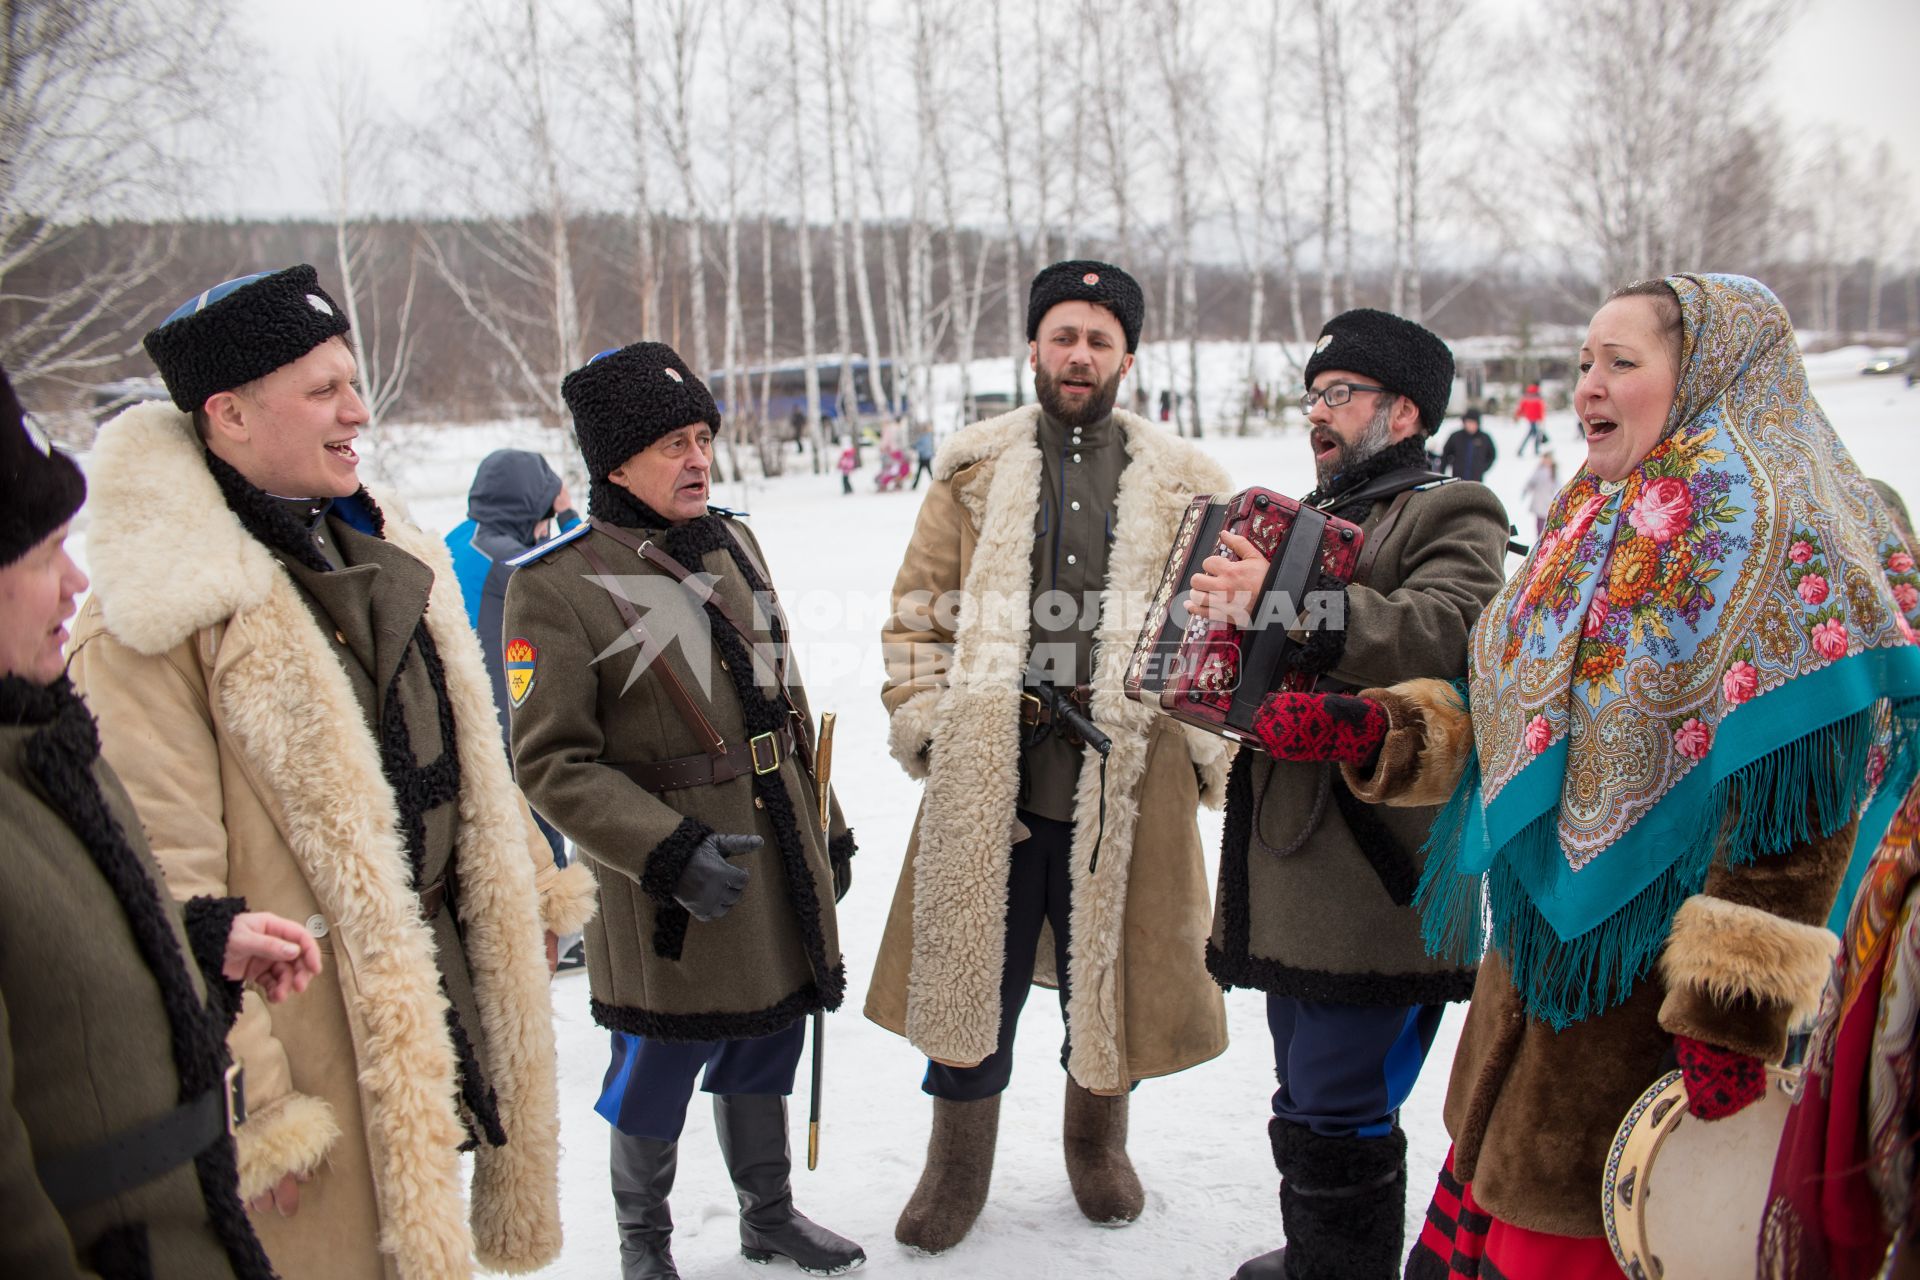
[71,405,593,1280]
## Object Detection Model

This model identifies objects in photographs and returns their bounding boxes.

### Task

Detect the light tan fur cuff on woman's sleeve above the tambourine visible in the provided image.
[1661,894,1839,1038]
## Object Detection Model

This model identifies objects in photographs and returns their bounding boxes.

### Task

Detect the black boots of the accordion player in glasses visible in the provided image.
[1233,1117,1407,1280]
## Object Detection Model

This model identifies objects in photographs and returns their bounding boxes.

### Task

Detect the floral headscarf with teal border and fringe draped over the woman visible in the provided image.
[1421,276,1920,1027]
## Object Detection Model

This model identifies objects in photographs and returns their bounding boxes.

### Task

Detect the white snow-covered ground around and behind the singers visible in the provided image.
[77,344,1920,1280]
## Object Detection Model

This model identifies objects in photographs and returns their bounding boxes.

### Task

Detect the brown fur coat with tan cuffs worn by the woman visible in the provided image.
[1342,679,1855,1236]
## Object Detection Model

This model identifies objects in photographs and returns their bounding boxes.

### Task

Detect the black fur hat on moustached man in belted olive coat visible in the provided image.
[561,342,720,480]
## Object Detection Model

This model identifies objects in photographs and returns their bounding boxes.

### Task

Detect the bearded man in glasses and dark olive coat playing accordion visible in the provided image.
[1188,311,1507,1280]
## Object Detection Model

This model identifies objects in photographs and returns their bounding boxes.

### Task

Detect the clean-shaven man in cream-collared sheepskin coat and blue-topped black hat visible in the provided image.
[73,267,593,1280]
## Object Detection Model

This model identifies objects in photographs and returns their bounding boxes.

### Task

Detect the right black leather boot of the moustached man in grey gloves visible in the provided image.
[714,1094,866,1276]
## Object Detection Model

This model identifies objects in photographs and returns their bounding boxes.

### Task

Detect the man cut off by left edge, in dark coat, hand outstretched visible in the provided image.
[0,360,321,1280]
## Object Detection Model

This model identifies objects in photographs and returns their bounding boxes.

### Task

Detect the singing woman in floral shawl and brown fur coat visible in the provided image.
[1251,276,1920,1280]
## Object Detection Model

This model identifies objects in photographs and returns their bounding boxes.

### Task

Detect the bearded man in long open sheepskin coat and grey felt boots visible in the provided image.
[866,261,1229,1253]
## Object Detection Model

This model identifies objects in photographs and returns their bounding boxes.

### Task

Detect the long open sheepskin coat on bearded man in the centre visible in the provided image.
[866,405,1231,1094]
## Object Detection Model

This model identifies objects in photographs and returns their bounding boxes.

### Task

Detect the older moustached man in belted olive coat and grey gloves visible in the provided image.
[505,342,866,1280]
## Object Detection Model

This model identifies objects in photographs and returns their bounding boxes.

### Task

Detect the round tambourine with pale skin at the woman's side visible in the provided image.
[1599,1067,1799,1280]
